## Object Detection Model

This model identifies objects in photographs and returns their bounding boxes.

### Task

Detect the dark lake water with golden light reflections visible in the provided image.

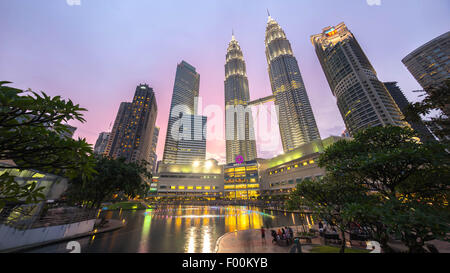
[30,206,311,253]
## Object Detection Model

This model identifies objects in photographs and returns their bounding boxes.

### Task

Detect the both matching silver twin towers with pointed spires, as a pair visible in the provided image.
[225,15,320,164]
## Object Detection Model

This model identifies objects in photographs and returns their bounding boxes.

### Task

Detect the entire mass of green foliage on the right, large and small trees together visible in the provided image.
[293,126,450,252]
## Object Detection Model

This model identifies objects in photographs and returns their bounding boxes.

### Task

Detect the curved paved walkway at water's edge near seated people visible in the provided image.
[216,227,320,253]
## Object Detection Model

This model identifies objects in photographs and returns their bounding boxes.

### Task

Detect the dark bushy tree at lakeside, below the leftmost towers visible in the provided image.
[67,157,151,208]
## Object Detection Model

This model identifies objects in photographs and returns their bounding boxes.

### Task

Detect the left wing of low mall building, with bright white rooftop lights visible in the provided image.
[158,160,223,200]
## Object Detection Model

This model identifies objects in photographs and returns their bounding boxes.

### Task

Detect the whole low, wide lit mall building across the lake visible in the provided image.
[152,136,348,200]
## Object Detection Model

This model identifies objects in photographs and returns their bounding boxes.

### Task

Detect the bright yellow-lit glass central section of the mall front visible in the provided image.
[224,160,260,200]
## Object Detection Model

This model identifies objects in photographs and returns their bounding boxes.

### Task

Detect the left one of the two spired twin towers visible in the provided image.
[224,35,256,163]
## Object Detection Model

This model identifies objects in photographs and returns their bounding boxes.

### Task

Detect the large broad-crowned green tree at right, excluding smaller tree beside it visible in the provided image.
[319,126,450,252]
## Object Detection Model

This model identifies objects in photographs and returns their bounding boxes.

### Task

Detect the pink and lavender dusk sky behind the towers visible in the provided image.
[0,0,450,160]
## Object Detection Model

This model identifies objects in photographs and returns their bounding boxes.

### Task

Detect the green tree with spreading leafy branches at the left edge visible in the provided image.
[0,81,93,208]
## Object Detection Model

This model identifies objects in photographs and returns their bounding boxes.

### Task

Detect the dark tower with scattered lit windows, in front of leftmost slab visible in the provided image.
[118,84,158,167]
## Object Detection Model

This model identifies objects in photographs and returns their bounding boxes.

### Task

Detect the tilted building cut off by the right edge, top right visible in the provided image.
[402,31,450,91]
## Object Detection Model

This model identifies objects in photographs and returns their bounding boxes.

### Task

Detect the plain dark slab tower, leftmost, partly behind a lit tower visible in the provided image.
[104,102,131,158]
